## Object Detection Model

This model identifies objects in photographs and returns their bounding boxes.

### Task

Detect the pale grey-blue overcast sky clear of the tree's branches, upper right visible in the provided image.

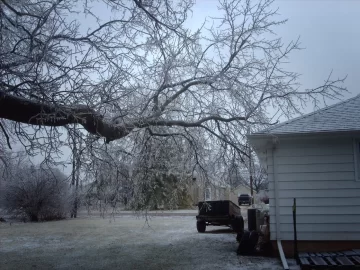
[191,0,360,112]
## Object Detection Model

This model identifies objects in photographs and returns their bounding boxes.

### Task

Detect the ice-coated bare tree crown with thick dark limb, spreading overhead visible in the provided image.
[0,0,345,206]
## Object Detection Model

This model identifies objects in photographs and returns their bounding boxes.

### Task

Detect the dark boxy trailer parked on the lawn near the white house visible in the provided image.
[196,200,244,233]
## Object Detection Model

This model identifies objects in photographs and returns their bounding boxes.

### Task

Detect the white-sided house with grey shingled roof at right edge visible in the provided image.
[248,95,360,255]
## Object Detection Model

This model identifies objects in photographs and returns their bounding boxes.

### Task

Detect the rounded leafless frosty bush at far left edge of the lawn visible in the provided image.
[4,167,72,221]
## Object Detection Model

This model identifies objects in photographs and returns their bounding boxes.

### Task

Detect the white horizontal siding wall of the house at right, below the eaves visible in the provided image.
[266,137,360,240]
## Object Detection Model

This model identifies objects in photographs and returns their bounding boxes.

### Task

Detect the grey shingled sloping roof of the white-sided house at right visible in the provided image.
[252,95,360,135]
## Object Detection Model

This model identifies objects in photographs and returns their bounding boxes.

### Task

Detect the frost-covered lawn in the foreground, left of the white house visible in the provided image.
[0,215,296,270]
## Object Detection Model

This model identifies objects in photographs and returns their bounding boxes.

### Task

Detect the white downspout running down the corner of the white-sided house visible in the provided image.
[272,143,289,270]
